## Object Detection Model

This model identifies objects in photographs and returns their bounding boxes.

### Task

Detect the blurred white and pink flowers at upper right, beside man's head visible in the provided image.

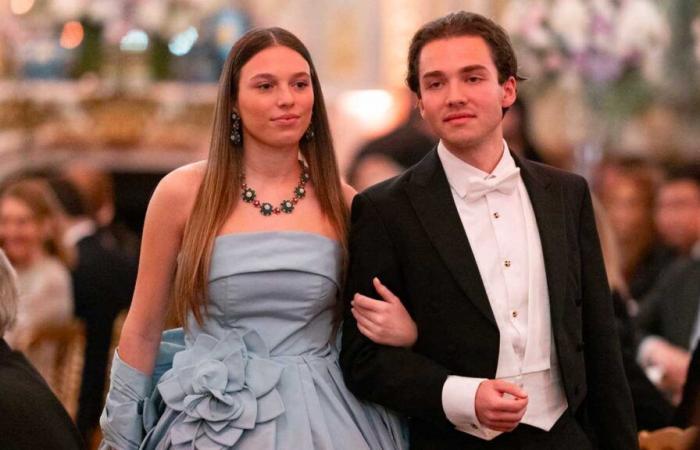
[502,0,671,115]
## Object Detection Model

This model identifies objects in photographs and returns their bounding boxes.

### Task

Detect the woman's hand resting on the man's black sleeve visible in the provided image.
[351,277,418,348]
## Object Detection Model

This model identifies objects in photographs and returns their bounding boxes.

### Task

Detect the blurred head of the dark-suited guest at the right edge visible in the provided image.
[654,163,700,258]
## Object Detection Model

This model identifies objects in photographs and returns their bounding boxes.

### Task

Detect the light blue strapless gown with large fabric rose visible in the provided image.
[141,231,407,450]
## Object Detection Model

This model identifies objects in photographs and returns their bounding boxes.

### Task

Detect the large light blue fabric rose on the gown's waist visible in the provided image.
[158,330,284,448]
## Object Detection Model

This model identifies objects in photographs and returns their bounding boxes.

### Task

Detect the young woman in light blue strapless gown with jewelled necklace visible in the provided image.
[102,28,416,450]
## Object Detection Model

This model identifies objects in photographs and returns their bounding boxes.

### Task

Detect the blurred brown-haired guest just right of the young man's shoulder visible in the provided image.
[596,159,675,301]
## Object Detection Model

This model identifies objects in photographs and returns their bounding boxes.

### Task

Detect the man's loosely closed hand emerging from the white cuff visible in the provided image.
[474,380,527,432]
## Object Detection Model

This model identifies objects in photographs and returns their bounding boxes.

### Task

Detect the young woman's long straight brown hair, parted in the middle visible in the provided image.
[173,27,348,326]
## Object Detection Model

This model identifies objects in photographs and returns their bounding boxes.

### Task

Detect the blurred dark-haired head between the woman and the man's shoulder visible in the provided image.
[347,108,437,192]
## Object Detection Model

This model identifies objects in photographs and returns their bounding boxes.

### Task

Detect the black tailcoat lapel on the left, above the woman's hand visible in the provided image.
[406,149,496,326]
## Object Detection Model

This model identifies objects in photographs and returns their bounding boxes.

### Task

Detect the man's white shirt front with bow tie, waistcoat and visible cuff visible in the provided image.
[438,141,568,440]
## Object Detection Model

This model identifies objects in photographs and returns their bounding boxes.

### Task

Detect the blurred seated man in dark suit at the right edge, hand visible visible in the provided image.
[638,168,700,408]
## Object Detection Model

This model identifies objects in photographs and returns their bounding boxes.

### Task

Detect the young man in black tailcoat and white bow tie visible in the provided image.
[341,12,636,450]
